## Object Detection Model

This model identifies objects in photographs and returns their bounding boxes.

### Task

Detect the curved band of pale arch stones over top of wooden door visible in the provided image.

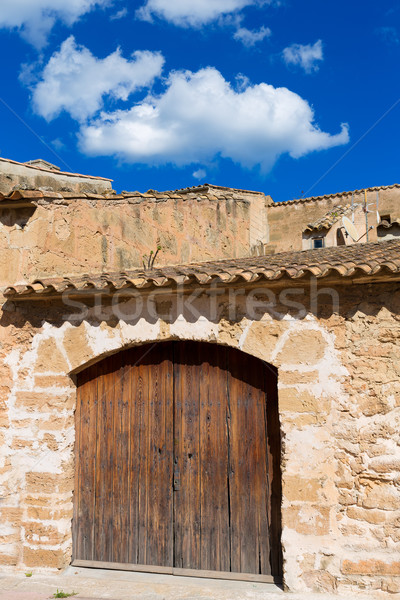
[50,315,334,374]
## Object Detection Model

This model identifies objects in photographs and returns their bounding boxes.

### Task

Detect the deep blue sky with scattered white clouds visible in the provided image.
[0,0,400,201]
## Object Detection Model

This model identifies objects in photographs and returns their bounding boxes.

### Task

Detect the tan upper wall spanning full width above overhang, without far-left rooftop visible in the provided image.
[0,178,400,286]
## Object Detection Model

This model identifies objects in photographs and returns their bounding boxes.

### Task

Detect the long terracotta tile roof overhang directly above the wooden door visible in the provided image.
[4,240,400,301]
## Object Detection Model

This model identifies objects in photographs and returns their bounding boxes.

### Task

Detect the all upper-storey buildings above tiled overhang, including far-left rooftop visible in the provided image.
[0,152,400,286]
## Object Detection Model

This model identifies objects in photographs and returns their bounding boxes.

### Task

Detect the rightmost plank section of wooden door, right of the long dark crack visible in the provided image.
[228,350,270,574]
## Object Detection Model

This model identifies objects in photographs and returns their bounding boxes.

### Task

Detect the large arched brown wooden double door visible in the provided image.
[73,342,281,581]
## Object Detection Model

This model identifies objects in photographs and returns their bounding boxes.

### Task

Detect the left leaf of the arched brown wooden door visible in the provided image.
[73,344,173,566]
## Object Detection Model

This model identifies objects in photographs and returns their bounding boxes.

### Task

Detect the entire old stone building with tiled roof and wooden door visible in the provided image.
[0,159,400,598]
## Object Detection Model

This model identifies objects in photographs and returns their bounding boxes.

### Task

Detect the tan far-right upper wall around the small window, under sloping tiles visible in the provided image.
[265,187,400,254]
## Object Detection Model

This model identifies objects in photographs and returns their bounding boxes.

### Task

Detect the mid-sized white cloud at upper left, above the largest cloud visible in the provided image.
[33,36,164,120]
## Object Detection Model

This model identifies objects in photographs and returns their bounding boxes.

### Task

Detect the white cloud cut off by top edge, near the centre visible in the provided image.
[136,0,260,27]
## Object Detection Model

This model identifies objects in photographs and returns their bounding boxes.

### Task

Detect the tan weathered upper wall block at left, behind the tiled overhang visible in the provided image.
[0,196,256,286]
